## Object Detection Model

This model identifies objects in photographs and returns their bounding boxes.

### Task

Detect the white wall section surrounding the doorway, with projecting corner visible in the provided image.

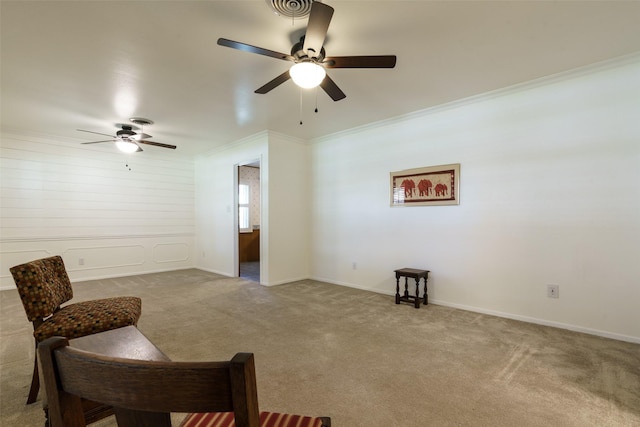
[196,131,309,285]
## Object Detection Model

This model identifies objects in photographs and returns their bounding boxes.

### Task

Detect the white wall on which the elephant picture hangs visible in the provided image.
[310,57,640,342]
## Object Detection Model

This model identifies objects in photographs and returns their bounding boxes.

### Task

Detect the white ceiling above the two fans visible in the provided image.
[0,0,640,156]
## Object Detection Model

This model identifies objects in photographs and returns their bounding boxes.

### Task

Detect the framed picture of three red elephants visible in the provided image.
[391,163,460,206]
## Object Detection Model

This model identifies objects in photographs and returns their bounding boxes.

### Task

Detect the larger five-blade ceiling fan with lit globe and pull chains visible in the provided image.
[218,1,396,101]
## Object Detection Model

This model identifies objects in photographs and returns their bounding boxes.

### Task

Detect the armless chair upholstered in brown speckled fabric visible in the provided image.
[10,256,142,404]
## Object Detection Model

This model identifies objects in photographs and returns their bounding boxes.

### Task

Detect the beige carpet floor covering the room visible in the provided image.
[0,269,640,427]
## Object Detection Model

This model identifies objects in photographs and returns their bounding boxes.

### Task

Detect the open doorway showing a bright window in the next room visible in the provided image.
[237,160,260,283]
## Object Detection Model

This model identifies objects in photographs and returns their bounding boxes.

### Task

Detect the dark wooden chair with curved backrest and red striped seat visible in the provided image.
[38,337,331,427]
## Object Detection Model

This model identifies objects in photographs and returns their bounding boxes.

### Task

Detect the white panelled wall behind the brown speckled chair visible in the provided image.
[0,132,194,289]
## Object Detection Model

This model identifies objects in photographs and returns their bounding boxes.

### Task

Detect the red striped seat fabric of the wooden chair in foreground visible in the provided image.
[180,412,322,427]
